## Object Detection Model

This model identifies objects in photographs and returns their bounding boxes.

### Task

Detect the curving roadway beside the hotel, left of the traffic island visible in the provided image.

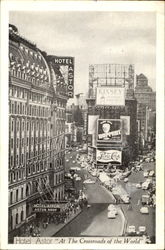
[55,152,125,237]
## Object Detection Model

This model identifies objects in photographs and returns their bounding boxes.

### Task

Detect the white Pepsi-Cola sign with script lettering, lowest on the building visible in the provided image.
[97,150,122,163]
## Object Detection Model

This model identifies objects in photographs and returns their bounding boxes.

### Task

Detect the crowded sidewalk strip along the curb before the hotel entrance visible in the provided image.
[40,209,82,237]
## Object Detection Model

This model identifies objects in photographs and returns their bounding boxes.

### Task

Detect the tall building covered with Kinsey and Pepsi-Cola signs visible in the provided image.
[86,64,137,167]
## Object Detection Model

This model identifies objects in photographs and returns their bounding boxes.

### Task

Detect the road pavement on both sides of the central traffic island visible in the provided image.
[56,151,155,237]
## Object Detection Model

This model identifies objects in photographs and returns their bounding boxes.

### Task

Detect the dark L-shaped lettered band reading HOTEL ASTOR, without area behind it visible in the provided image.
[54,56,74,98]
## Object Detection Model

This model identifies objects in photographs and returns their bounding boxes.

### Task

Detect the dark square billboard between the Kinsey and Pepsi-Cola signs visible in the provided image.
[97,119,122,143]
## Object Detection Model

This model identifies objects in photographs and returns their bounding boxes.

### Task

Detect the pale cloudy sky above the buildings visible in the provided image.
[9,11,156,100]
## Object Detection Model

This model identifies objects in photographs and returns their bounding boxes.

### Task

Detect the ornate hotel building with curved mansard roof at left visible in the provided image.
[8,25,71,235]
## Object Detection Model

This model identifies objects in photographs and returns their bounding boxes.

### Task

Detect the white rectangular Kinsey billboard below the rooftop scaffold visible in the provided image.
[96,86,125,106]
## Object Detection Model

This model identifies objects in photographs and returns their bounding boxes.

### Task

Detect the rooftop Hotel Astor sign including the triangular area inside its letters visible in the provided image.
[48,56,74,98]
